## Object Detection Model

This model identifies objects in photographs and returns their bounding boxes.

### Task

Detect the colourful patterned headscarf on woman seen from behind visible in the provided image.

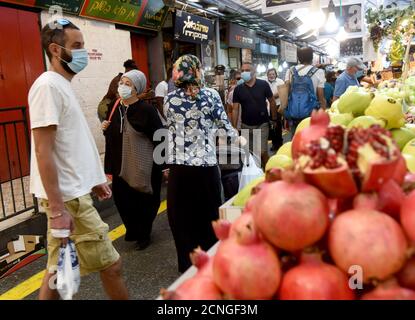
[172,54,203,98]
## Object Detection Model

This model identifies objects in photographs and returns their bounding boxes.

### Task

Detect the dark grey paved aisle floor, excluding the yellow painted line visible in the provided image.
[0,207,179,300]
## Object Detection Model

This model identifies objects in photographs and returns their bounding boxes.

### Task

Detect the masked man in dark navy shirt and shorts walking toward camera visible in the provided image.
[232,62,277,166]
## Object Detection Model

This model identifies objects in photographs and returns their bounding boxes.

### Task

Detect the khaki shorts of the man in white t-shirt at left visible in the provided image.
[40,195,120,275]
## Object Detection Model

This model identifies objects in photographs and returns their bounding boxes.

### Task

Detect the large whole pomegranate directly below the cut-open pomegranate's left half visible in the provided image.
[253,171,329,251]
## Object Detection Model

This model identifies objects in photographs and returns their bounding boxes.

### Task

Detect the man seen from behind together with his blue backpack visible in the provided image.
[284,48,327,135]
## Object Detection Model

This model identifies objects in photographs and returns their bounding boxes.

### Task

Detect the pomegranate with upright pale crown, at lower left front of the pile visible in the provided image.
[213,214,281,300]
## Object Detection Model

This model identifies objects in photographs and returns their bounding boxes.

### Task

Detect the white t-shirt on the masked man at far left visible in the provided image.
[29,71,107,202]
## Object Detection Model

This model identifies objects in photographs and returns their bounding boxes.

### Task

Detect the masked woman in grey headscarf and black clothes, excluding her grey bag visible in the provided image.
[102,70,163,250]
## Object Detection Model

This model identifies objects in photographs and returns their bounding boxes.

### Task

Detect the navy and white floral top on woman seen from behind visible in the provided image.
[164,88,238,167]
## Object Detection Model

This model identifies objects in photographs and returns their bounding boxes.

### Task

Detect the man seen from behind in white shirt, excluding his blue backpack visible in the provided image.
[280,47,327,134]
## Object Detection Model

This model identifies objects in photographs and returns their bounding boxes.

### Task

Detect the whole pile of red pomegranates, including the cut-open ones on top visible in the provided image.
[162,111,415,300]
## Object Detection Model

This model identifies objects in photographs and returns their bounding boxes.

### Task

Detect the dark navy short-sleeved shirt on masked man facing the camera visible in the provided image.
[233,79,273,126]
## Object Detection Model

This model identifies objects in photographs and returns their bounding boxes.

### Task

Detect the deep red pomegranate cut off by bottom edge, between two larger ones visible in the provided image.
[279,253,355,300]
